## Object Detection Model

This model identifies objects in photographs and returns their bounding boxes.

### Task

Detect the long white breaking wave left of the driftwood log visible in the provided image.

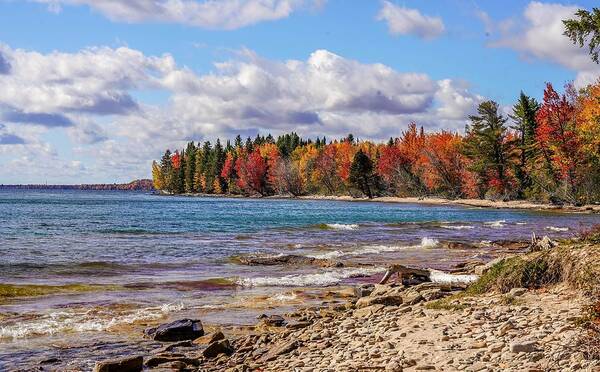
[238,268,385,287]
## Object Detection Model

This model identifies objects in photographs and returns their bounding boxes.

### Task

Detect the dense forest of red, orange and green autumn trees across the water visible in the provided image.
[152,83,600,204]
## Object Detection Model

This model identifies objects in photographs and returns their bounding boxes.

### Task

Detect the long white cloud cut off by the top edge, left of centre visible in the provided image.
[33,0,324,30]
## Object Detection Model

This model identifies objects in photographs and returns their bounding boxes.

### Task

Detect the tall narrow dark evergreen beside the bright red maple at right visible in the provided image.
[510,92,540,198]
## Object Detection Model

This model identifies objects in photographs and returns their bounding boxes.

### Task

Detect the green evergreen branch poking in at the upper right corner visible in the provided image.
[563,8,600,63]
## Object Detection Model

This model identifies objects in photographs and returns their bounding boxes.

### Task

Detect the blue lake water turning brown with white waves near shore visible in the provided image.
[0,190,600,369]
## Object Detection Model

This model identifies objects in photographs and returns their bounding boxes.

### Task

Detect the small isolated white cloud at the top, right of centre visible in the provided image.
[377,0,445,39]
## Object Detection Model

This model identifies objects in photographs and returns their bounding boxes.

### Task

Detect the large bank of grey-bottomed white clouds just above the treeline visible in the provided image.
[0,46,483,182]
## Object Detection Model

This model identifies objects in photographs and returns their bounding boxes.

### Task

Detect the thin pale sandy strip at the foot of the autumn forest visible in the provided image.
[157,191,600,213]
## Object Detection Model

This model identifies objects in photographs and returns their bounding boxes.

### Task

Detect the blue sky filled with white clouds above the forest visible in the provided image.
[0,0,600,184]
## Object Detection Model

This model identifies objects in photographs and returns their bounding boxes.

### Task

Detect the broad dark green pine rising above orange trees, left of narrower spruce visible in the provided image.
[464,101,514,198]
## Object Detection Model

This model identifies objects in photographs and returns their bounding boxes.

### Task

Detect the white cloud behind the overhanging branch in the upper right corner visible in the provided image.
[490,1,600,86]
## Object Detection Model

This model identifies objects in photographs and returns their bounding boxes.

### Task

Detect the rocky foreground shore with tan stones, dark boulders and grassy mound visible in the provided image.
[89,235,600,372]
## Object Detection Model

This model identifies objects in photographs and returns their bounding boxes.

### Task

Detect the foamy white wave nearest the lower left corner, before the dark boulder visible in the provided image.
[0,303,184,340]
